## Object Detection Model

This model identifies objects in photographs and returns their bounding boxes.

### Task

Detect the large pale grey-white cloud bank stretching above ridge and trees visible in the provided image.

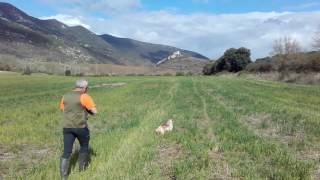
[77,11,320,58]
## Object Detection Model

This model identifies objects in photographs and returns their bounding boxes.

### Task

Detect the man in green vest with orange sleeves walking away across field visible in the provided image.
[60,80,97,179]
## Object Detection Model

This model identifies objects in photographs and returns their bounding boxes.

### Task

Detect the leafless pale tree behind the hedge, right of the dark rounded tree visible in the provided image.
[271,36,301,55]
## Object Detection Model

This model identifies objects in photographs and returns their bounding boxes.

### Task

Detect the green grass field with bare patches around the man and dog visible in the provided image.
[0,75,320,180]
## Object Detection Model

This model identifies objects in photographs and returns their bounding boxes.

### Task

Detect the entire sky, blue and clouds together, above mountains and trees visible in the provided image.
[5,0,320,59]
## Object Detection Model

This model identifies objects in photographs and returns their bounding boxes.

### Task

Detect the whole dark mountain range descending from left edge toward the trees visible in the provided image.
[0,2,208,66]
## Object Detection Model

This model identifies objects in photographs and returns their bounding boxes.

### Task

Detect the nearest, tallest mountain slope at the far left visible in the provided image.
[0,3,123,64]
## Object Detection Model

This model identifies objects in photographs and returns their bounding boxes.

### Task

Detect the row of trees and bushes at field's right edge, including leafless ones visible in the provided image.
[203,27,320,75]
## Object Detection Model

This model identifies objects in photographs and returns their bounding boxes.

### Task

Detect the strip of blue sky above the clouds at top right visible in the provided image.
[143,0,320,14]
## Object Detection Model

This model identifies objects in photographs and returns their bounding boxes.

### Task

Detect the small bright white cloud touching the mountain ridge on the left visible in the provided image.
[40,14,91,29]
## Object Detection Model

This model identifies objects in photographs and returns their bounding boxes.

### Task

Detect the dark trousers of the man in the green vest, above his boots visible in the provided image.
[62,127,90,159]
